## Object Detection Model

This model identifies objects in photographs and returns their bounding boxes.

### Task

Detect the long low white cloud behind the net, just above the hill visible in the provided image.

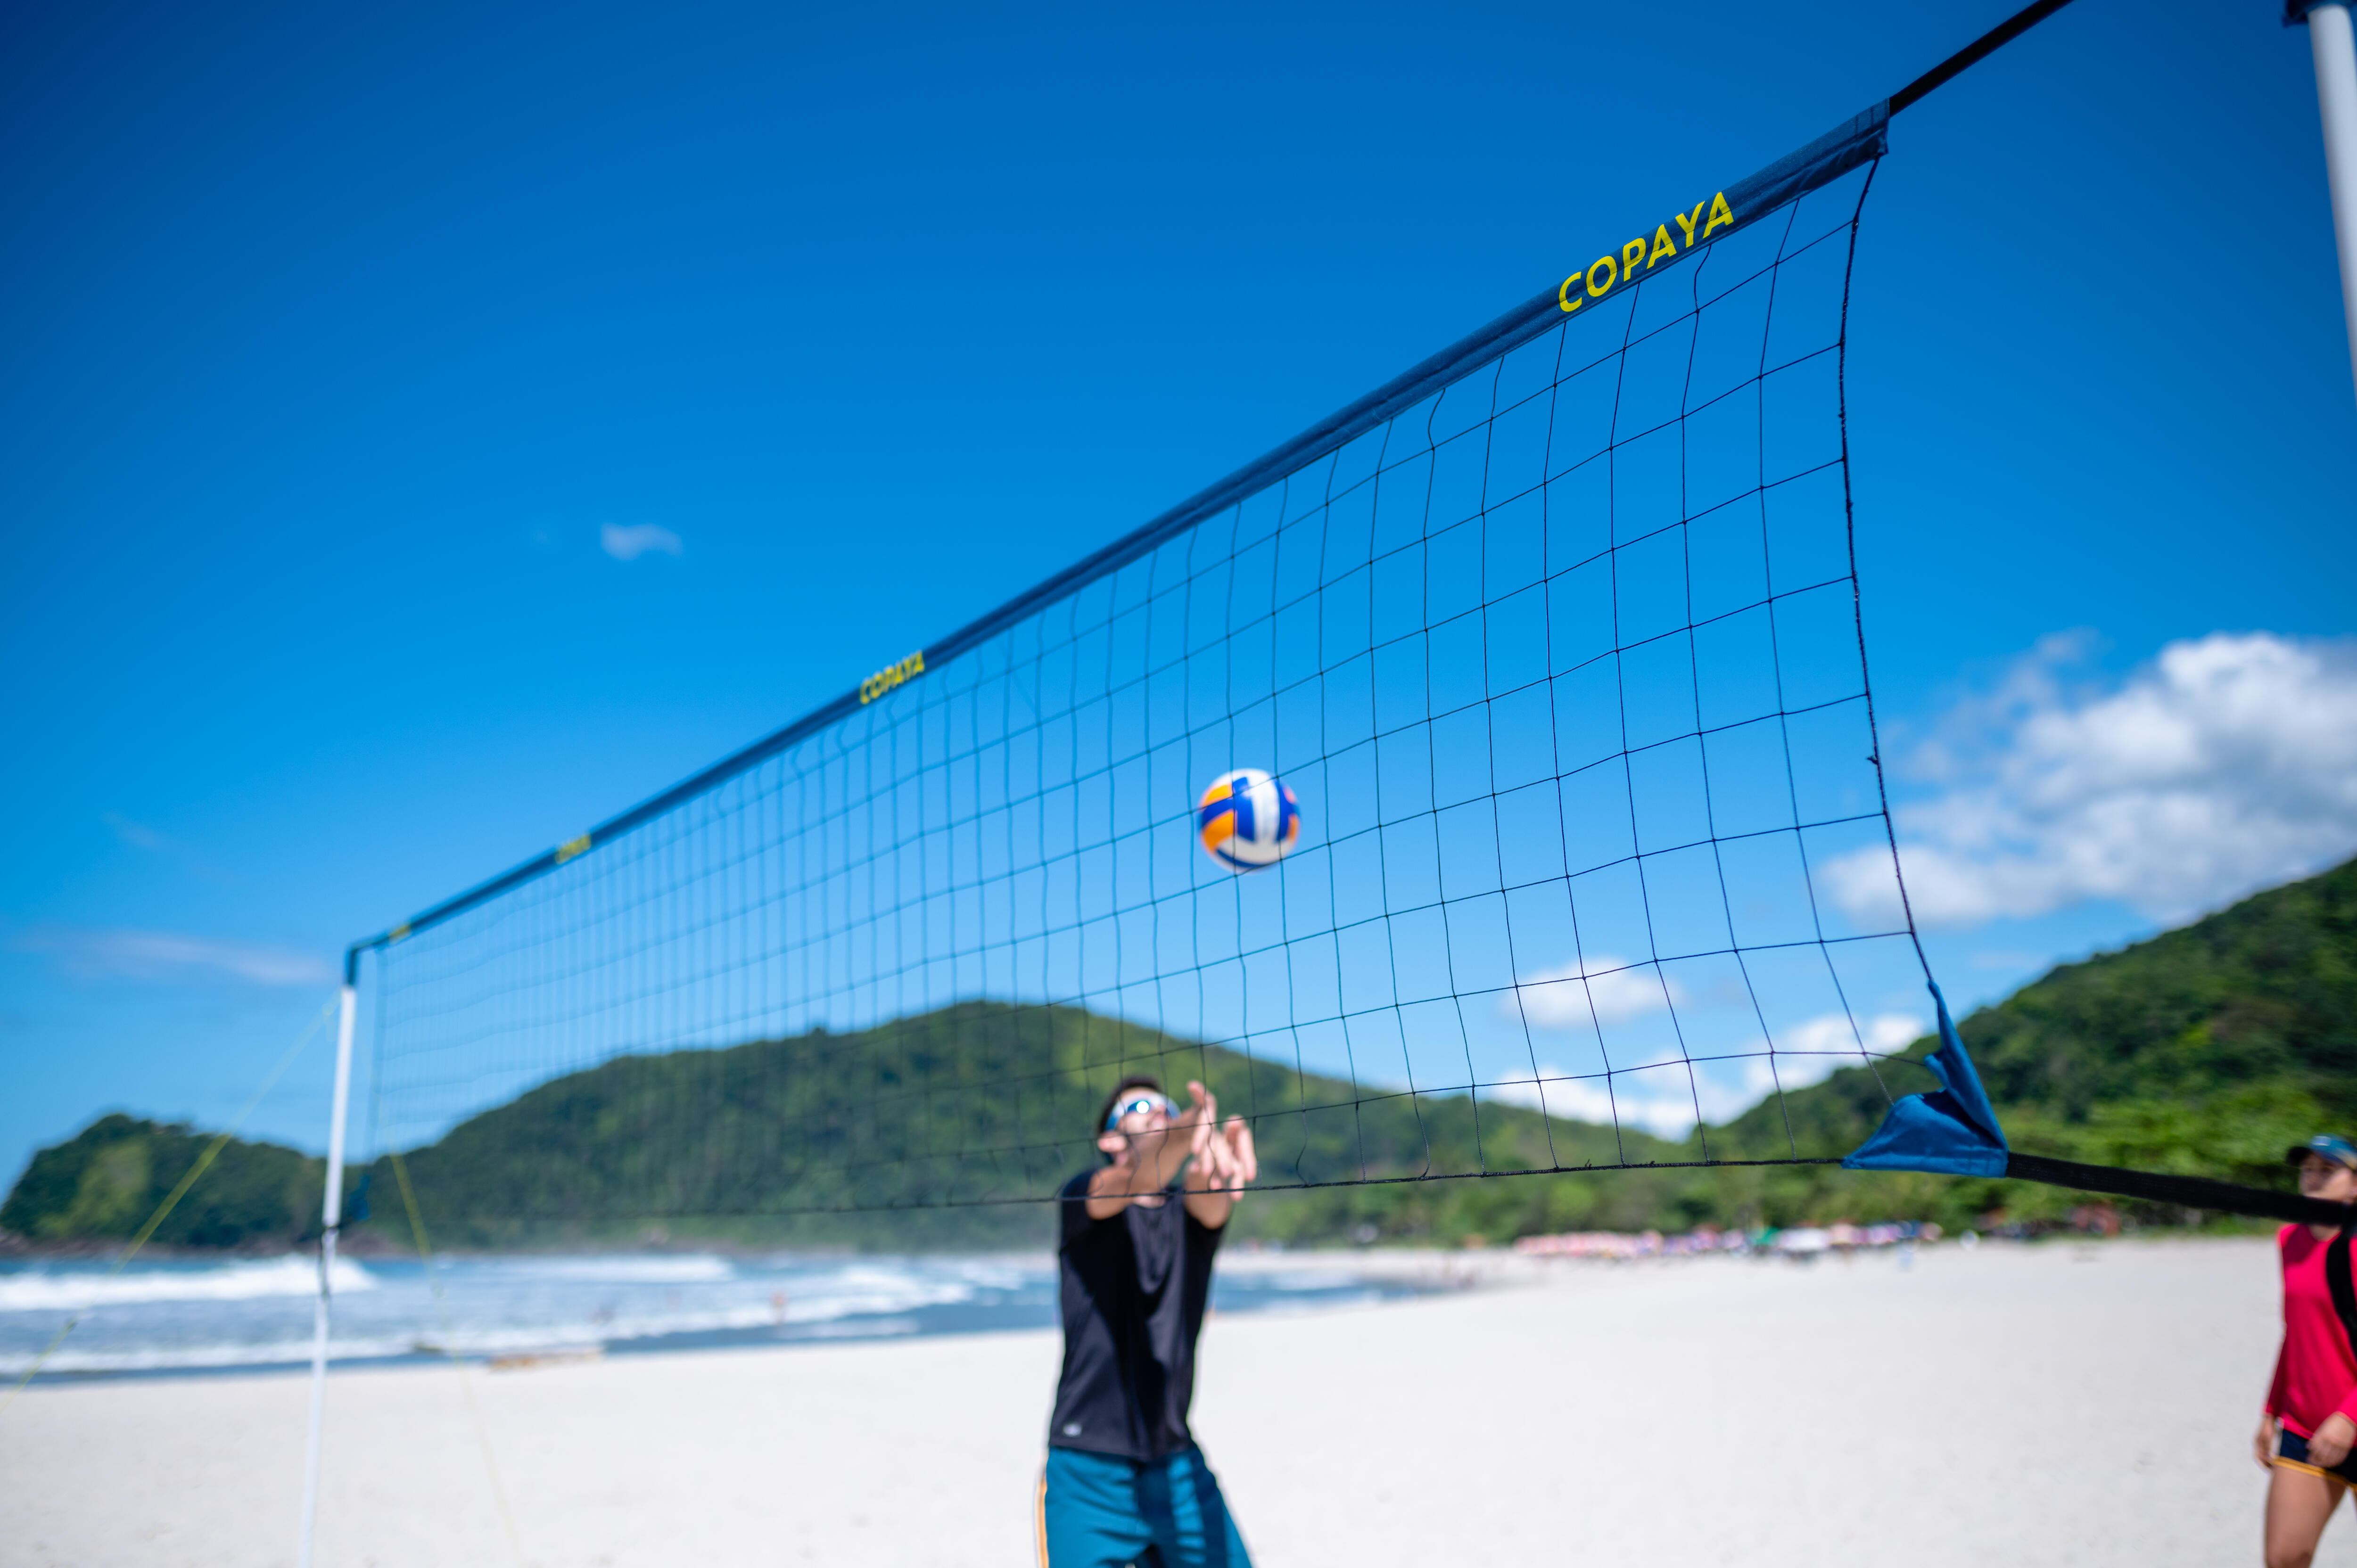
[1492,1011,1926,1139]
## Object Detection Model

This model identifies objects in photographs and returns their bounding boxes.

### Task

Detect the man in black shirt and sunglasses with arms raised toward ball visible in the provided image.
[1037,1077,1256,1568]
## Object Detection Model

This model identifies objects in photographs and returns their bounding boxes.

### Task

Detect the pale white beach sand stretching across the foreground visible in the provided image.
[0,1243,2357,1568]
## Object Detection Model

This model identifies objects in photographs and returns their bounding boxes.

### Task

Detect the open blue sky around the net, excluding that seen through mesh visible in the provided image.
[0,0,2357,1174]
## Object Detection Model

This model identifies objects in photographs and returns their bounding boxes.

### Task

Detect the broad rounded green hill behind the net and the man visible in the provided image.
[358,1002,1692,1248]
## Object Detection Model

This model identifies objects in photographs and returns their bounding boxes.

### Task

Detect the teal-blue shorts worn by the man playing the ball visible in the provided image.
[1037,1448,1252,1568]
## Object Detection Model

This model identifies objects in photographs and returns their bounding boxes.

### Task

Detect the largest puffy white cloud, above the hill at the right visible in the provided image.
[1829,632,2357,927]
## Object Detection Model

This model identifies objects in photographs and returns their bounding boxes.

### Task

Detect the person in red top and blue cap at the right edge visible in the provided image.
[2258,1134,2357,1568]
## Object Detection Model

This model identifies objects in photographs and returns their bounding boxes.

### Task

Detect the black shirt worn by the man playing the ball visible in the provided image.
[1047,1169,1219,1460]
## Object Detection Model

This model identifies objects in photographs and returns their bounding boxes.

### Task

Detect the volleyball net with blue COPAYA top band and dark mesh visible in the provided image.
[356,111,1928,1219]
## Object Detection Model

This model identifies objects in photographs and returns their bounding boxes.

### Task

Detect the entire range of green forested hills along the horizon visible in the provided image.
[0,863,2357,1248]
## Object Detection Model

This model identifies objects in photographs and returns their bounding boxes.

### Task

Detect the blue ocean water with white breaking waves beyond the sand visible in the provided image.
[0,1252,1414,1382]
